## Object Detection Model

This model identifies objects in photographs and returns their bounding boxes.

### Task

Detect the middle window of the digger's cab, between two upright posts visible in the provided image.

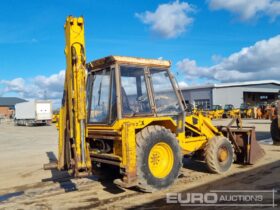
[120,66,151,115]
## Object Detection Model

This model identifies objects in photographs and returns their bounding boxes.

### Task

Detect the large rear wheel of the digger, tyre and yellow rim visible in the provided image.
[136,125,182,192]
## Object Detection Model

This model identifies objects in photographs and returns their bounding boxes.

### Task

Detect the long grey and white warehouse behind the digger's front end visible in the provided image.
[182,80,280,108]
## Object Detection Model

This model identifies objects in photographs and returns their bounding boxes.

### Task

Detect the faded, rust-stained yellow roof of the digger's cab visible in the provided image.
[87,55,171,70]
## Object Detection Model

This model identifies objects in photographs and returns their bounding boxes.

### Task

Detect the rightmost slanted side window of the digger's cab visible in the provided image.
[150,69,180,115]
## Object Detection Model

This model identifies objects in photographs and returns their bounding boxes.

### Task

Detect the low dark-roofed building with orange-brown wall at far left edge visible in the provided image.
[0,97,26,118]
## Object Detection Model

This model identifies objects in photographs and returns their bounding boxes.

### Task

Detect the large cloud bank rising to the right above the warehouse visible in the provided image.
[177,35,280,82]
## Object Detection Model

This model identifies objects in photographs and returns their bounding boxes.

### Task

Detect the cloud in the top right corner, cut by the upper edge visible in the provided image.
[208,0,280,20]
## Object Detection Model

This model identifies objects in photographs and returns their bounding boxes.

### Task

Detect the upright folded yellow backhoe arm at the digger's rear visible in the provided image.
[58,16,91,176]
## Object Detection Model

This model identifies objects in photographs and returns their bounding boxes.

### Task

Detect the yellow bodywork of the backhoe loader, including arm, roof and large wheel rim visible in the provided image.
[58,17,225,184]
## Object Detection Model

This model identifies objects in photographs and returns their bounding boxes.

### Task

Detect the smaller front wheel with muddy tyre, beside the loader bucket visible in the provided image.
[205,136,234,174]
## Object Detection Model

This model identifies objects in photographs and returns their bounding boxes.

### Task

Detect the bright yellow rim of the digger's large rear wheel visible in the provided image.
[148,142,174,178]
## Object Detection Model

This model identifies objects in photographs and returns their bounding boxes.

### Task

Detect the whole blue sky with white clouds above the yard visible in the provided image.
[0,0,280,106]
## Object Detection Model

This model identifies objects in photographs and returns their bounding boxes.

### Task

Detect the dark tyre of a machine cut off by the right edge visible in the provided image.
[270,101,280,145]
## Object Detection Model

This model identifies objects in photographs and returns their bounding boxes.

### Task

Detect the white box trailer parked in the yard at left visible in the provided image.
[14,100,52,126]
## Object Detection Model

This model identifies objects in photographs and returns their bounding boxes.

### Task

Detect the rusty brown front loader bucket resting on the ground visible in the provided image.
[221,118,265,164]
